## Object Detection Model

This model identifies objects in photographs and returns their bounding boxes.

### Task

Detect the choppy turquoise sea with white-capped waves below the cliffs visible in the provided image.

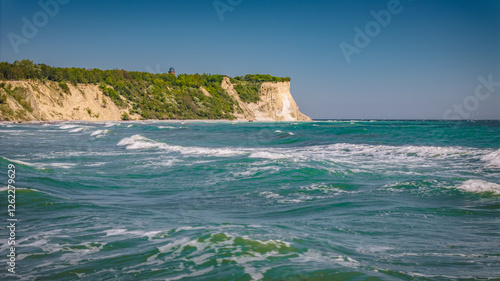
[0,121,500,280]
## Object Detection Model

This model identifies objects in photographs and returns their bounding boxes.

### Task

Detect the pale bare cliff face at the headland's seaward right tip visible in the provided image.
[222,77,311,121]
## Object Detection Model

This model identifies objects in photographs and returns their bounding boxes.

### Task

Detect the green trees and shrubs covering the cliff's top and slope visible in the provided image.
[0,60,290,119]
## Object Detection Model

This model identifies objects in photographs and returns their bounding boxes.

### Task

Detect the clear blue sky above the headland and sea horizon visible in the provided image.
[0,0,500,120]
